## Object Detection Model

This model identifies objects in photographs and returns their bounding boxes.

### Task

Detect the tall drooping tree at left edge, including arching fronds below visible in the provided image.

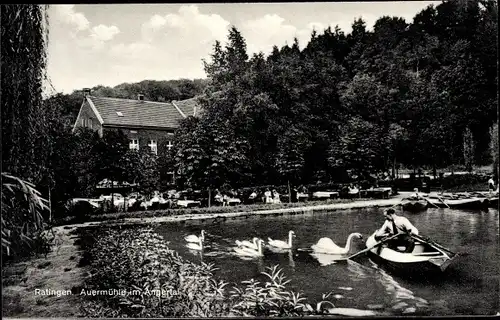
[0,4,50,263]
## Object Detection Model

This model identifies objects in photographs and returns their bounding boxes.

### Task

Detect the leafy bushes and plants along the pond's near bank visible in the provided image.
[79,228,333,317]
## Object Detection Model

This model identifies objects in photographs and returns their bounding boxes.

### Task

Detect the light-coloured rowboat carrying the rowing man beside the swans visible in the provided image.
[366,233,459,276]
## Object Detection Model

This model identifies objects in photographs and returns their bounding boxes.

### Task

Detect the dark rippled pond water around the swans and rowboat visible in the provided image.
[157,208,500,315]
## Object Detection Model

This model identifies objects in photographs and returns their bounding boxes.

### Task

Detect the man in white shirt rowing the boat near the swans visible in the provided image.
[375,208,418,253]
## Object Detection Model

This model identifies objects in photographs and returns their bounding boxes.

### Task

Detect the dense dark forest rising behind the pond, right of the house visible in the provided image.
[171,1,498,190]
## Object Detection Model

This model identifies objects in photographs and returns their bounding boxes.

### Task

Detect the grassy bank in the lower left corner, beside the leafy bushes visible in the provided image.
[2,228,86,318]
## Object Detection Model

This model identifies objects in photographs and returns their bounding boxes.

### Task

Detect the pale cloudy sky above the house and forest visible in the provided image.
[47,1,440,93]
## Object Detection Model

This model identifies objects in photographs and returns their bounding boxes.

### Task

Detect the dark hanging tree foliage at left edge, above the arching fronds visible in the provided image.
[1,5,49,184]
